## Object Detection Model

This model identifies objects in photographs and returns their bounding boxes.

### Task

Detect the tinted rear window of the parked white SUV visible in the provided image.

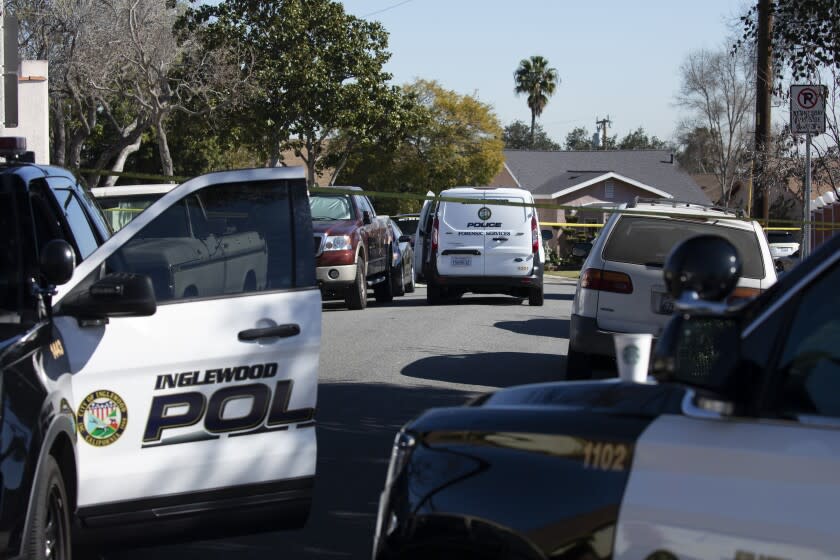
[603,216,764,279]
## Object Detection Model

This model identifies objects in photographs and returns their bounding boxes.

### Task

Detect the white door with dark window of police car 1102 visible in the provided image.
[614,253,840,560]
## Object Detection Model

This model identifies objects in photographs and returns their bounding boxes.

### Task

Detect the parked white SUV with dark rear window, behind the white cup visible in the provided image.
[566,199,776,379]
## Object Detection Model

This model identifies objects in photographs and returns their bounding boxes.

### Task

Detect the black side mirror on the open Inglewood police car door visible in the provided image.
[57,272,157,324]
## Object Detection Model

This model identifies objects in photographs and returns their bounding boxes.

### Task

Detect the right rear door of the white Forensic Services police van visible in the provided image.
[482,193,535,277]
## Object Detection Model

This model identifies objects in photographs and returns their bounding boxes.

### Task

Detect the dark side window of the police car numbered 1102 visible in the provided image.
[779,264,840,418]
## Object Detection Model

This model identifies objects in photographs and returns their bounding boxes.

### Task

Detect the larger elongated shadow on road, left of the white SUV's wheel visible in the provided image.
[402,352,566,387]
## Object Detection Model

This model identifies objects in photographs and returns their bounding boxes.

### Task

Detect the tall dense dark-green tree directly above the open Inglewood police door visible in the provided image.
[185,0,402,184]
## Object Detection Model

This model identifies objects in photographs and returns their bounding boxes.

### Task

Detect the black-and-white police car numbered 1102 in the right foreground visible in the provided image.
[373,232,840,560]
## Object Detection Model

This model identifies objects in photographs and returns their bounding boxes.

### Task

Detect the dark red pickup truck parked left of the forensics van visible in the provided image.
[309,187,394,309]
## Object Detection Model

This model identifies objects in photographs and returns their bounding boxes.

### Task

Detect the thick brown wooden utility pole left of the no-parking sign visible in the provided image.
[752,0,773,226]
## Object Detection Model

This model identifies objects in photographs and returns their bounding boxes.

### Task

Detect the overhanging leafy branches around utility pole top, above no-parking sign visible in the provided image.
[736,0,840,81]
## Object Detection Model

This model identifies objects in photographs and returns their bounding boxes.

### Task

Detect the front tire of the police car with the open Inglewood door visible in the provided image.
[24,455,72,560]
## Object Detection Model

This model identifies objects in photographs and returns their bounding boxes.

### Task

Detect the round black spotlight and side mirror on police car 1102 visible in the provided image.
[651,235,741,413]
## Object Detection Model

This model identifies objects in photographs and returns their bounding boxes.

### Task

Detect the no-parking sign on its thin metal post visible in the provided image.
[790,84,828,259]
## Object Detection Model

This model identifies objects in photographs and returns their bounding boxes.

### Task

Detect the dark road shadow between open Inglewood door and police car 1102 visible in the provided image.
[113,383,474,560]
